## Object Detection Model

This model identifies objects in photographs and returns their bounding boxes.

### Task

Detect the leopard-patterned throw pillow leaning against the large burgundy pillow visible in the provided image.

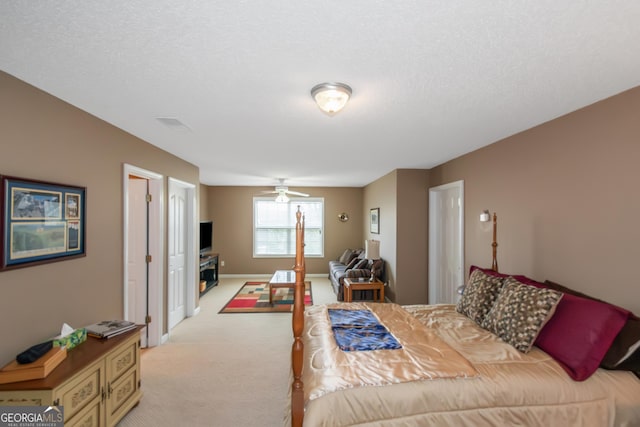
[481,277,562,353]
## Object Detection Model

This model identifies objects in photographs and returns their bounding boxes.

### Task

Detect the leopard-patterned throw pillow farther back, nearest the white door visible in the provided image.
[456,269,504,325]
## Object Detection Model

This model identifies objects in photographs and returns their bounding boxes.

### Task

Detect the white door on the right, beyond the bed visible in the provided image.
[429,181,464,304]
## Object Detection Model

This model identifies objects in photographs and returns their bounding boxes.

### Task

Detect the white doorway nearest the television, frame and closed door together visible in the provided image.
[167,178,197,331]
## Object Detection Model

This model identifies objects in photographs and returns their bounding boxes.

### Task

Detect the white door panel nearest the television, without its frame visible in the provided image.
[168,184,188,329]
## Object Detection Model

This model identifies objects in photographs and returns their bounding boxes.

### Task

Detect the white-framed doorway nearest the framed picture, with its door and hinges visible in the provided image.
[123,164,164,347]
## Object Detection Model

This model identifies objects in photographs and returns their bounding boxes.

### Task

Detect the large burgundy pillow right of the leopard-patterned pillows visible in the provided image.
[535,294,629,381]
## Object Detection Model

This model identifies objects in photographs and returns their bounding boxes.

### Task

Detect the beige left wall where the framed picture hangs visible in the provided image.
[0,72,199,364]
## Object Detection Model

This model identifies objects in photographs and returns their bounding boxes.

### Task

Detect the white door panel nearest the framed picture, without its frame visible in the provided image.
[126,177,148,347]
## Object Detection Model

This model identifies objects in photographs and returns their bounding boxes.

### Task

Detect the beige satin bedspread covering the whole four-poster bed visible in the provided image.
[303,304,640,427]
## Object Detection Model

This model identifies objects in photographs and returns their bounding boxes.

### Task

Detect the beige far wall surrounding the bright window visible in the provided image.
[203,186,364,274]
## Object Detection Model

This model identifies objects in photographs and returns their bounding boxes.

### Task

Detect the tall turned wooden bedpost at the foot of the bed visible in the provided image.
[291,206,305,427]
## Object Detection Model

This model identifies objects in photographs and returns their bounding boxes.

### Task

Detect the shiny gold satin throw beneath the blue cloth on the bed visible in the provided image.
[303,303,476,400]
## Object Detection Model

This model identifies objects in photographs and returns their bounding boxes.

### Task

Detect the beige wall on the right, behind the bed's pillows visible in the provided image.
[430,88,640,313]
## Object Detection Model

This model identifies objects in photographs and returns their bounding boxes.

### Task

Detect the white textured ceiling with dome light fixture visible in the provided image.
[0,0,640,186]
